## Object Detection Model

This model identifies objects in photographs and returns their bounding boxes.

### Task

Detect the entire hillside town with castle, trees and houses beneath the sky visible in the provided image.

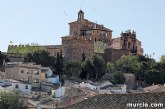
[0,10,165,109]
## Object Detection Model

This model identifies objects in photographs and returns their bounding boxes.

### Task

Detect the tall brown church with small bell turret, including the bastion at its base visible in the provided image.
[62,10,112,60]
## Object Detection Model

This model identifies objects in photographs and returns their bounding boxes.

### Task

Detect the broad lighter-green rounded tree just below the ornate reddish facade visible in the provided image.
[116,55,141,74]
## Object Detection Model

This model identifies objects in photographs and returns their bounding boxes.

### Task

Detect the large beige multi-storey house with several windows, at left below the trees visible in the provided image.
[5,62,53,88]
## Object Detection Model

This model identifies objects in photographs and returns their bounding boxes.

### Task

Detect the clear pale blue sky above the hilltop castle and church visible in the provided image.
[0,0,165,60]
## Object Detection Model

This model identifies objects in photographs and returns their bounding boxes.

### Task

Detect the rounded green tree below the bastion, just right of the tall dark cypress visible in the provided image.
[64,60,81,78]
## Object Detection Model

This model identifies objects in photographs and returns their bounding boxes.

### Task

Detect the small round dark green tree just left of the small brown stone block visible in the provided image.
[112,71,126,84]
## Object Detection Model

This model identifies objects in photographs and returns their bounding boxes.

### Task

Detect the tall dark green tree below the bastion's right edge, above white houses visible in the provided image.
[91,55,106,81]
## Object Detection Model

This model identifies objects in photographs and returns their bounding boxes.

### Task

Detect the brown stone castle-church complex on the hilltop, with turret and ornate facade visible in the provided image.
[9,10,143,62]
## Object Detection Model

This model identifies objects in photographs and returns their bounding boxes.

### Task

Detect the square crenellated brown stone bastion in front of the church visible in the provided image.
[62,36,94,61]
